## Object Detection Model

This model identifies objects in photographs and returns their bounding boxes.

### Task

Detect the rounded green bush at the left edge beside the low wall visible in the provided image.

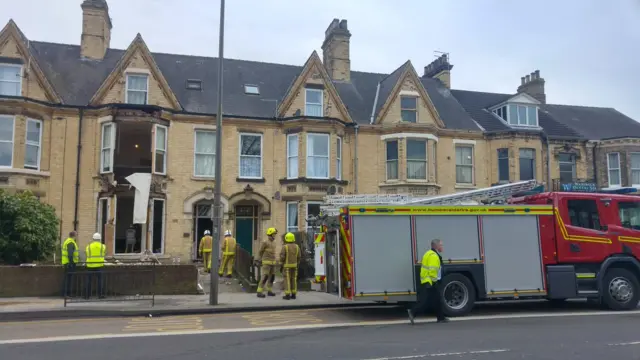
[0,190,59,265]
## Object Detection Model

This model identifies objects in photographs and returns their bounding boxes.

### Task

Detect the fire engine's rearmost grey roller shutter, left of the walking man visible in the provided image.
[350,212,416,302]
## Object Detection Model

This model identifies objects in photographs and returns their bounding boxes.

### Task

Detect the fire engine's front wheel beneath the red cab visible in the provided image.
[602,268,640,310]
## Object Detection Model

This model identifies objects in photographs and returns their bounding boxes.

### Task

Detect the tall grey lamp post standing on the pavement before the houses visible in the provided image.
[209,0,224,305]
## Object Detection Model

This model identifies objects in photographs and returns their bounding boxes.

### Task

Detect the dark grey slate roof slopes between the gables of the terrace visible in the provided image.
[20,41,640,140]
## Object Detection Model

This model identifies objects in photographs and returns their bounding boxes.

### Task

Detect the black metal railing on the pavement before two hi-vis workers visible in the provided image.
[62,261,156,307]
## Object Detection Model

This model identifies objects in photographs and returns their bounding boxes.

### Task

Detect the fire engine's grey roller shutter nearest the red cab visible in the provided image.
[482,215,545,297]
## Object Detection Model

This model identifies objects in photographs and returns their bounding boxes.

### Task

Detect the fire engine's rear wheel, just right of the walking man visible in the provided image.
[442,274,476,316]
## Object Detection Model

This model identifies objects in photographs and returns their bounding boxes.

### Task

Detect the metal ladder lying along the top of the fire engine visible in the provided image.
[321,180,538,215]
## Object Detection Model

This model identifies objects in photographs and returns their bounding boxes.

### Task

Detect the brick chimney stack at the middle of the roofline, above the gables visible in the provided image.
[322,19,351,81]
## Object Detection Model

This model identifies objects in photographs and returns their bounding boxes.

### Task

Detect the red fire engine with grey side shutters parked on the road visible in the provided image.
[322,180,640,316]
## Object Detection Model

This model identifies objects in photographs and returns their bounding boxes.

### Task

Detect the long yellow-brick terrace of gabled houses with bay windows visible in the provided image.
[0,0,640,260]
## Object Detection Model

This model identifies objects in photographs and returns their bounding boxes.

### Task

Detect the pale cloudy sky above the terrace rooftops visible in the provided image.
[0,0,640,121]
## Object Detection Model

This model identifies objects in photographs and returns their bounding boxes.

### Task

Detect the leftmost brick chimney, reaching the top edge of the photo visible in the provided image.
[80,0,112,60]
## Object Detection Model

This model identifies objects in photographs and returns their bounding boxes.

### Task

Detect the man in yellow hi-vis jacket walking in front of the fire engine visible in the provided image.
[407,239,449,324]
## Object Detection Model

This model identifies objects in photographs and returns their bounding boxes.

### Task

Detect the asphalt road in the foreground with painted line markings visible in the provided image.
[0,303,640,360]
